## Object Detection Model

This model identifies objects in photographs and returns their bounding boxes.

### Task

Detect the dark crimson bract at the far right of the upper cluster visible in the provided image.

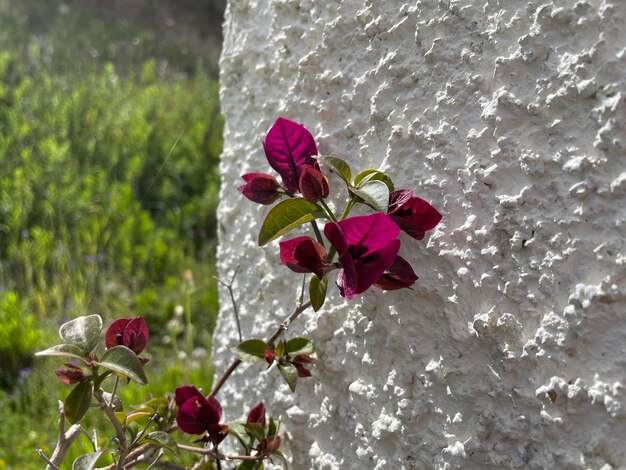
[387,189,441,240]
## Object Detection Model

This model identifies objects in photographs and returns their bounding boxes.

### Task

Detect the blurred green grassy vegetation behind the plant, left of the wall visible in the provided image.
[0,0,224,469]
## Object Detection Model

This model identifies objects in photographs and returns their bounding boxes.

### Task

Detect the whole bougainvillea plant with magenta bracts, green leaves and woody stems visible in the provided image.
[38,118,441,470]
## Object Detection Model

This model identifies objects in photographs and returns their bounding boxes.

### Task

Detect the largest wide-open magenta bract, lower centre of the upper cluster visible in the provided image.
[324,213,400,299]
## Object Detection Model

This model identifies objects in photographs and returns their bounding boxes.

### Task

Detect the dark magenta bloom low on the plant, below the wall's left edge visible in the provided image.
[175,386,228,446]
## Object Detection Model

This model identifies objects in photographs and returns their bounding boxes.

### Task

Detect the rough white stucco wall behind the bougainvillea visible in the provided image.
[216,0,626,470]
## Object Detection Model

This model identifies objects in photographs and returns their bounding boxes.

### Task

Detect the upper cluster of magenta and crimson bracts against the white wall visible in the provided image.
[238,118,441,299]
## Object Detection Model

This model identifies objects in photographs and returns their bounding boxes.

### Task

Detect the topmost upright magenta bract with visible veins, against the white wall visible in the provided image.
[263,118,319,194]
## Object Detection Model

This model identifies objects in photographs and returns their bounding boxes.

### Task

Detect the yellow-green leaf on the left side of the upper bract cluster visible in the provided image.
[259,198,323,246]
